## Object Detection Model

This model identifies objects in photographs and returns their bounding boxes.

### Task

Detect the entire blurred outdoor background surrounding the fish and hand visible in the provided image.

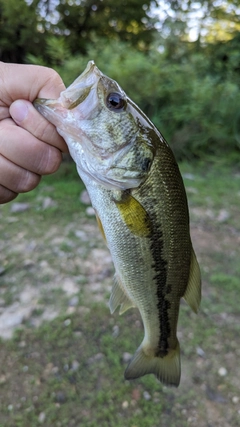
[0,0,240,427]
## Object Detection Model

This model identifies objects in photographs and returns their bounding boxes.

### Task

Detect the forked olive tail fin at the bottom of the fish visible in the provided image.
[124,342,181,387]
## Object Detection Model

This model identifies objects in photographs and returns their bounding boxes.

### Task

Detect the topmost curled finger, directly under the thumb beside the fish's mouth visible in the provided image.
[9,100,68,152]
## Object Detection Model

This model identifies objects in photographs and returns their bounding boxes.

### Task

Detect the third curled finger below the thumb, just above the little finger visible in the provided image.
[0,156,41,193]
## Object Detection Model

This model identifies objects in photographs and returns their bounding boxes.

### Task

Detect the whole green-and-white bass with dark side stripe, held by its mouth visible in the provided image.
[34,61,201,387]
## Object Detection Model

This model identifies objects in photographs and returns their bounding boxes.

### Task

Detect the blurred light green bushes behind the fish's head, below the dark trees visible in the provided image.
[48,39,240,160]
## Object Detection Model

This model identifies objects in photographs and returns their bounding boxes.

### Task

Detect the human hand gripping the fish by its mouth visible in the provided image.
[0,62,68,204]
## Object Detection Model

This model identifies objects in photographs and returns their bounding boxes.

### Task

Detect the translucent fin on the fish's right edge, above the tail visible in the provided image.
[183,249,201,313]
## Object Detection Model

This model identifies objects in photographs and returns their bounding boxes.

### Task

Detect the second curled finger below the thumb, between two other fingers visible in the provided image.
[0,119,62,175]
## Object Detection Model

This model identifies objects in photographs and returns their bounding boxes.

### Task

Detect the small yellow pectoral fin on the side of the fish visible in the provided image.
[114,194,151,237]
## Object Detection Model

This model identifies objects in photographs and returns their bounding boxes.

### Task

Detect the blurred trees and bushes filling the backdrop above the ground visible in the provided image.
[0,0,240,159]
